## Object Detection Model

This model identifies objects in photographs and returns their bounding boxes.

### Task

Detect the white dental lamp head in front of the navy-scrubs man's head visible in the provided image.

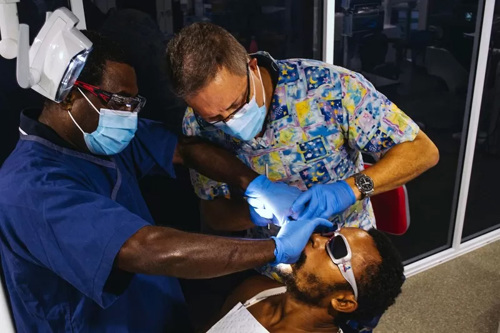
[17,7,92,102]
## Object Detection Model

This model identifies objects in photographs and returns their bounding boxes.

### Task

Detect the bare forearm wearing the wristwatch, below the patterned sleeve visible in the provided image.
[346,131,439,199]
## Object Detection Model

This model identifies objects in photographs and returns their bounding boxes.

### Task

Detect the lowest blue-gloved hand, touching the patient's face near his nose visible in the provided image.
[271,218,333,265]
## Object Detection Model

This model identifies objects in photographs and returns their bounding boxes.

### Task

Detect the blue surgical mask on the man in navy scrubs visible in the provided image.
[68,91,138,155]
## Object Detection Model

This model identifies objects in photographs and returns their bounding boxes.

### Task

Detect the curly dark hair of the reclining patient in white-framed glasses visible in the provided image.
[335,228,405,323]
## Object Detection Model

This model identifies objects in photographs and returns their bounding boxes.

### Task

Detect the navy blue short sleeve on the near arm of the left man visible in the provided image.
[10,174,149,307]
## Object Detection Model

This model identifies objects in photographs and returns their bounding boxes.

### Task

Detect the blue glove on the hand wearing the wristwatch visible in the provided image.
[292,180,356,219]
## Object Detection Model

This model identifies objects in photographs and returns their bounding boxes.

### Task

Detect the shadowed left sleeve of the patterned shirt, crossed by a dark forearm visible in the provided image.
[182,107,230,200]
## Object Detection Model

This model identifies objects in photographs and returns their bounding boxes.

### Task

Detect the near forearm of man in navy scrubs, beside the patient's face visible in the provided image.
[116,226,275,279]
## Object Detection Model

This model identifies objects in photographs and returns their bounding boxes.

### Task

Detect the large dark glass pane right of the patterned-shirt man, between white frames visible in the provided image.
[334,0,478,263]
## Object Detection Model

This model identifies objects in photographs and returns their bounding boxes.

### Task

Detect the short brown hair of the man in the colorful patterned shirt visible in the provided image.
[166,22,248,98]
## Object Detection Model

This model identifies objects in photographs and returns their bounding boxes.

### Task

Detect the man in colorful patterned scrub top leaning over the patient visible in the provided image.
[167,22,439,331]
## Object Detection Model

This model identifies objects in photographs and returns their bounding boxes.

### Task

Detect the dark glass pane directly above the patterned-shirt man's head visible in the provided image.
[162,0,323,59]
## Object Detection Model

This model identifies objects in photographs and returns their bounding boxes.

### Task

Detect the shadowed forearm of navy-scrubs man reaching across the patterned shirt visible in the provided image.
[178,137,259,190]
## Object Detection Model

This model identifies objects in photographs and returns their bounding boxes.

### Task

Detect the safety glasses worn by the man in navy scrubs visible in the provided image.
[75,81,146,113]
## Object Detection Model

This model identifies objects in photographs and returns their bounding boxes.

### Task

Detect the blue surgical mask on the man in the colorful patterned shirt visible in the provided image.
[215,67,267,141]
